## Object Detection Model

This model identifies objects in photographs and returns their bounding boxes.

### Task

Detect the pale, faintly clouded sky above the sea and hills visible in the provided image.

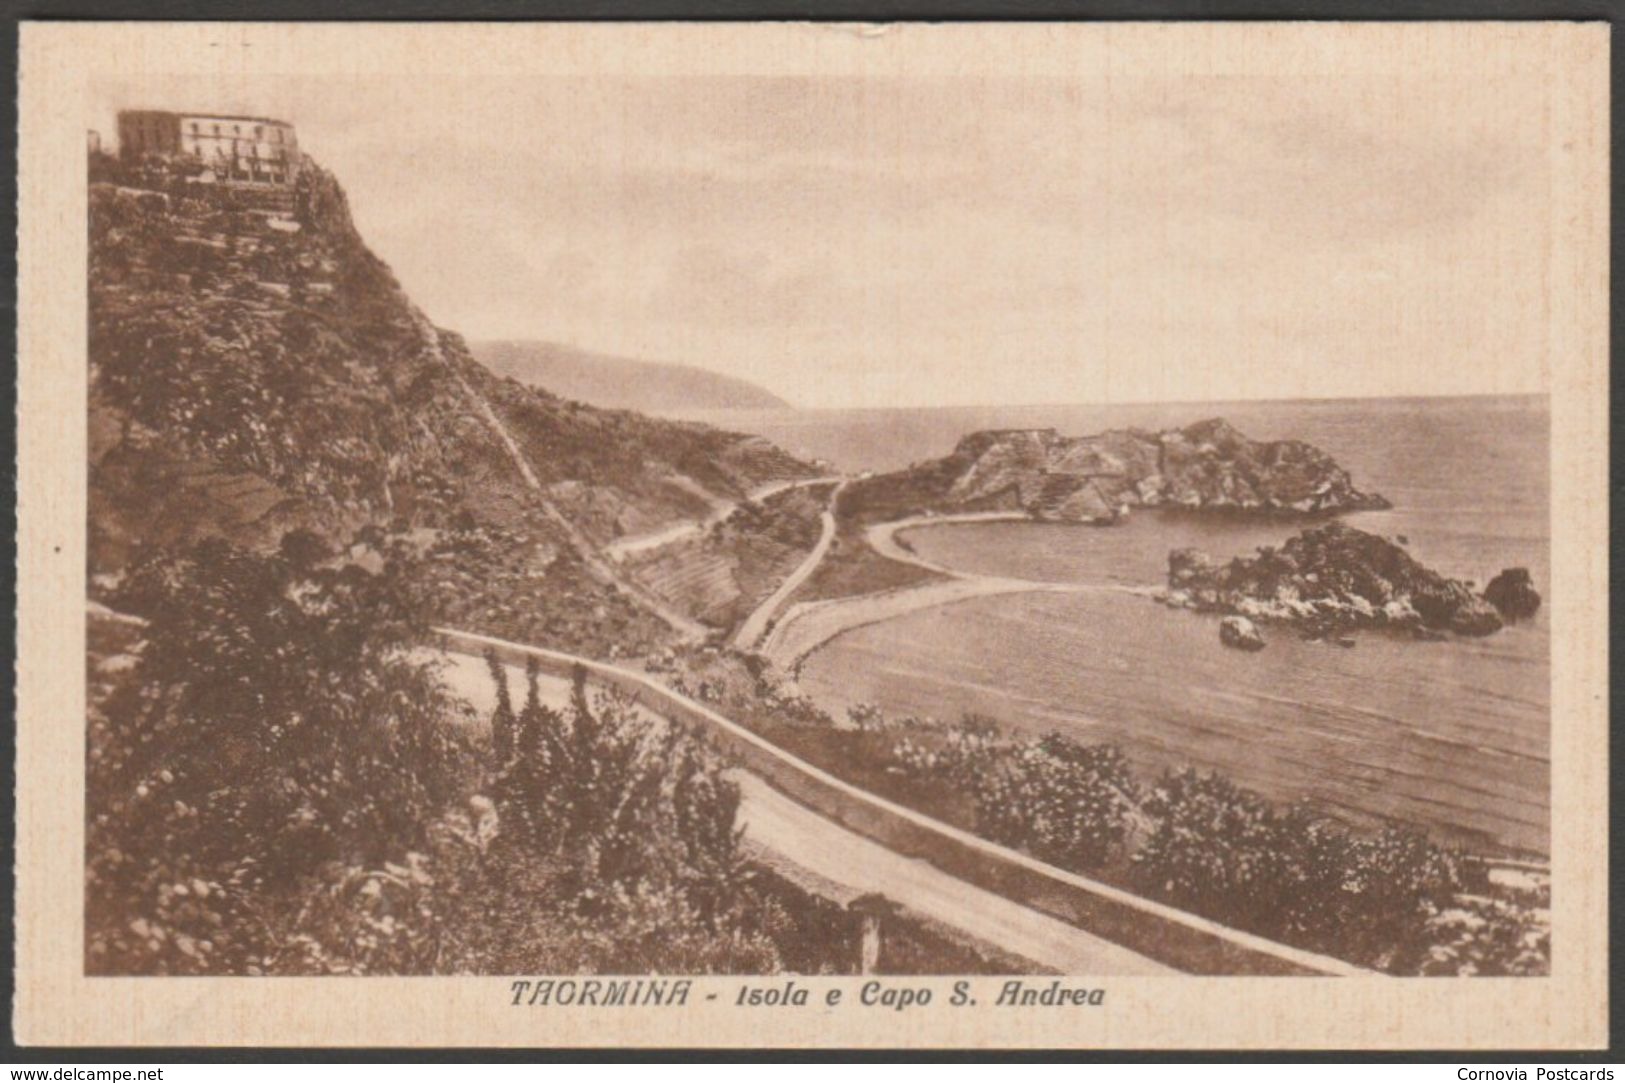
[93,58,1554,407]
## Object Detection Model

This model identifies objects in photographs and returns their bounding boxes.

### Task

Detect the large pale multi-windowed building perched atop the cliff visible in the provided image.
[119,109,299,185]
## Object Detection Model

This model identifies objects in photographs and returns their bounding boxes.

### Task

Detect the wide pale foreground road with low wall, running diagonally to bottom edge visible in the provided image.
[434,628,1370,976]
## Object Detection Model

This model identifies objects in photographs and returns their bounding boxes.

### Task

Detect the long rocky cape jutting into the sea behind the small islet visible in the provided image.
[852,418,1388,524]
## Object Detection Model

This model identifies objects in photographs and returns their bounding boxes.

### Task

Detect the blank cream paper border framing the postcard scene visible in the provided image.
[15,23,1609,1049]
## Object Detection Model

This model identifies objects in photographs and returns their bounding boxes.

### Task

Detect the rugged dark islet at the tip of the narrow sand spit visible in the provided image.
[1164,522,1502,637]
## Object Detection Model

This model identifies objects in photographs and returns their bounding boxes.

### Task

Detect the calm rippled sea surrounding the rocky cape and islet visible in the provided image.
[709,397,1550,854]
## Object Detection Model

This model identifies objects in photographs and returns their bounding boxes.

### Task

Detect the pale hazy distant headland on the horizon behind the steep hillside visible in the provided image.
[470,341,790,416]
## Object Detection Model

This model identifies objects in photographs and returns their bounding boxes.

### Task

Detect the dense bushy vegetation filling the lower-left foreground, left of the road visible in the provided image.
[86,533,786,974]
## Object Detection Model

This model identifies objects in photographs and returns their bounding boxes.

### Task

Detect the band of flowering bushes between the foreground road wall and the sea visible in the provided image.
[734,706,1550,974]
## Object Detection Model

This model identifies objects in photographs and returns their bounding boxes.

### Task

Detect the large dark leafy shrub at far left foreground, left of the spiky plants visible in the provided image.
[86,540,470,972]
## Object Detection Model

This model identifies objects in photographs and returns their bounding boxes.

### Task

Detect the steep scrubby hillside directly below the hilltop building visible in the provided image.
[89,150,811,649]
